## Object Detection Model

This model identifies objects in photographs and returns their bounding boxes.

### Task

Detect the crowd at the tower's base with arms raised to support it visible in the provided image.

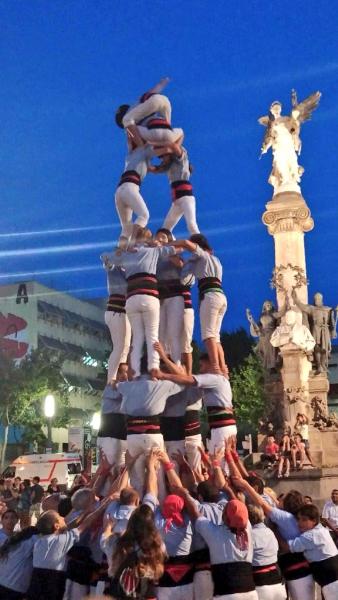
[0,437,338,600]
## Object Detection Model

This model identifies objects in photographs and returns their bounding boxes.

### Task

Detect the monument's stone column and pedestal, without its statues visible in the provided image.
[262,191,332,466]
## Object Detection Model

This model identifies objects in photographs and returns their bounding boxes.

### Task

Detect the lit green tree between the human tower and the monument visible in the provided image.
[231,353,265,429]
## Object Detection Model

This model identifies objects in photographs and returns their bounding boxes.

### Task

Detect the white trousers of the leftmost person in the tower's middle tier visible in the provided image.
[104,310,131,383]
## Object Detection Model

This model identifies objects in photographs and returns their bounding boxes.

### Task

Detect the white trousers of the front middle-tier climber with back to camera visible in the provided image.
[126,294,160,377]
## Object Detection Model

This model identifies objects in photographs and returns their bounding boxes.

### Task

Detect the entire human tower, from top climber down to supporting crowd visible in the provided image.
[0,80,338,600]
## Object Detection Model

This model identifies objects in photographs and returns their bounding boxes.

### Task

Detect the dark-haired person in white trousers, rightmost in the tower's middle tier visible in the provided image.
[171,233,228,374]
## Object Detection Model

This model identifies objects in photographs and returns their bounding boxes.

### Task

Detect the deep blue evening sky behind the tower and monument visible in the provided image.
[0,0,338,330]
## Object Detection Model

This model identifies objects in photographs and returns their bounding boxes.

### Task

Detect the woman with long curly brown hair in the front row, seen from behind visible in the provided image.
[110,506,165,600]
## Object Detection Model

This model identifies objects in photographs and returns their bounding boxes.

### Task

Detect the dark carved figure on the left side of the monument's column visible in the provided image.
[246,300,286,373]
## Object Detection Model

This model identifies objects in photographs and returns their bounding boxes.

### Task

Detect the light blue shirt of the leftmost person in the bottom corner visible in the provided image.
[0,527,37,600]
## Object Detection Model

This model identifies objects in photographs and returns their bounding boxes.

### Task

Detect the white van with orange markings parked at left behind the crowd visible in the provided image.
[2,452,82,489]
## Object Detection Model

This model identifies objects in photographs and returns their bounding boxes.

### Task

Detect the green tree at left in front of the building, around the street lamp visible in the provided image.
[0,349,69,436]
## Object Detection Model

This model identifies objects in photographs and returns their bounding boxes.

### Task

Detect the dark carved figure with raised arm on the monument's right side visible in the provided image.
[291,289,337,374]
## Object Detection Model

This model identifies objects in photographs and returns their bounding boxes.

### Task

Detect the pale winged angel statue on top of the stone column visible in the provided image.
[258,90,321,194]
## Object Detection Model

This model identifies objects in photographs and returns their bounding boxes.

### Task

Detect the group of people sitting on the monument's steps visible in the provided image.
[261,413,314,479]
